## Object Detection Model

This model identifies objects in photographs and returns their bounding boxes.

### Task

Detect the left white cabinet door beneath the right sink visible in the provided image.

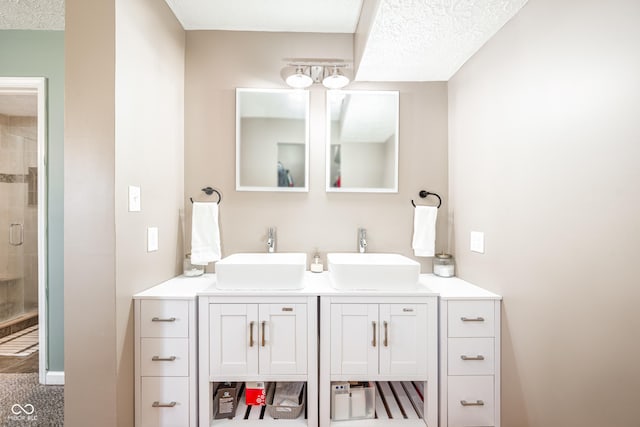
[330,304,380,375]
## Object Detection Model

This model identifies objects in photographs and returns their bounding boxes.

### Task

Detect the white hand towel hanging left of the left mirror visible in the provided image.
[191,202,221,265]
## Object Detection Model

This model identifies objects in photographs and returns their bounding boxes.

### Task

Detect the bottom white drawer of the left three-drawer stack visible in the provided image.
[141,377,189,427]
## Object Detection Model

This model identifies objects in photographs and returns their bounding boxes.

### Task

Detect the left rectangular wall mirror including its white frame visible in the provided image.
[236,88,309,191]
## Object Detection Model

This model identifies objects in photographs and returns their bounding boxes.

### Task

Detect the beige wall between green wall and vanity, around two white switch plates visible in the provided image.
[65,0,184,427]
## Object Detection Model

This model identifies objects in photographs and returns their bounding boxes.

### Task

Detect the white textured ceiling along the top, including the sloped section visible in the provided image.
[0,0,527,81]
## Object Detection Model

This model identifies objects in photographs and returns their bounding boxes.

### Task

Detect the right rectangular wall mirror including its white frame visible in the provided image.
[326,90,400,193]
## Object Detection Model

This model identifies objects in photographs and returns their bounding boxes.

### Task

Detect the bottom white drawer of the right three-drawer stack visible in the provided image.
[447,375,495,427]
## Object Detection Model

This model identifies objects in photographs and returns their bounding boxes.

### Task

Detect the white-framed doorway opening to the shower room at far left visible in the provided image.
[0,78,47,384]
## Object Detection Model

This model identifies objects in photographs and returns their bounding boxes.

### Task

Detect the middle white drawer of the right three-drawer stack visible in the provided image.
[447,338,495,375]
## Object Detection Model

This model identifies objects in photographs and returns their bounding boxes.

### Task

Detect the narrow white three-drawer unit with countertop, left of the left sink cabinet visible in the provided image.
[133,277,211,427]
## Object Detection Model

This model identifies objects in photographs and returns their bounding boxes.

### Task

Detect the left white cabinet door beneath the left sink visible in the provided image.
[209,304,259,376]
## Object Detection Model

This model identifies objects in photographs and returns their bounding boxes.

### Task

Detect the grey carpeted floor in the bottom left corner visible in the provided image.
[0,373,64,427]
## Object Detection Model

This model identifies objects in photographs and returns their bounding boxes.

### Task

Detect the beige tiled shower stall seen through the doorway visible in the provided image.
[0,91,38,336]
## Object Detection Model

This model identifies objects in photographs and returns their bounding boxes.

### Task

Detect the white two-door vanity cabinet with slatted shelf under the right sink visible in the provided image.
[320,291,438,427]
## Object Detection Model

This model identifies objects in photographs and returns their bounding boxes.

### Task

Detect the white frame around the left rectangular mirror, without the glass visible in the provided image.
[236,88,310,193]
